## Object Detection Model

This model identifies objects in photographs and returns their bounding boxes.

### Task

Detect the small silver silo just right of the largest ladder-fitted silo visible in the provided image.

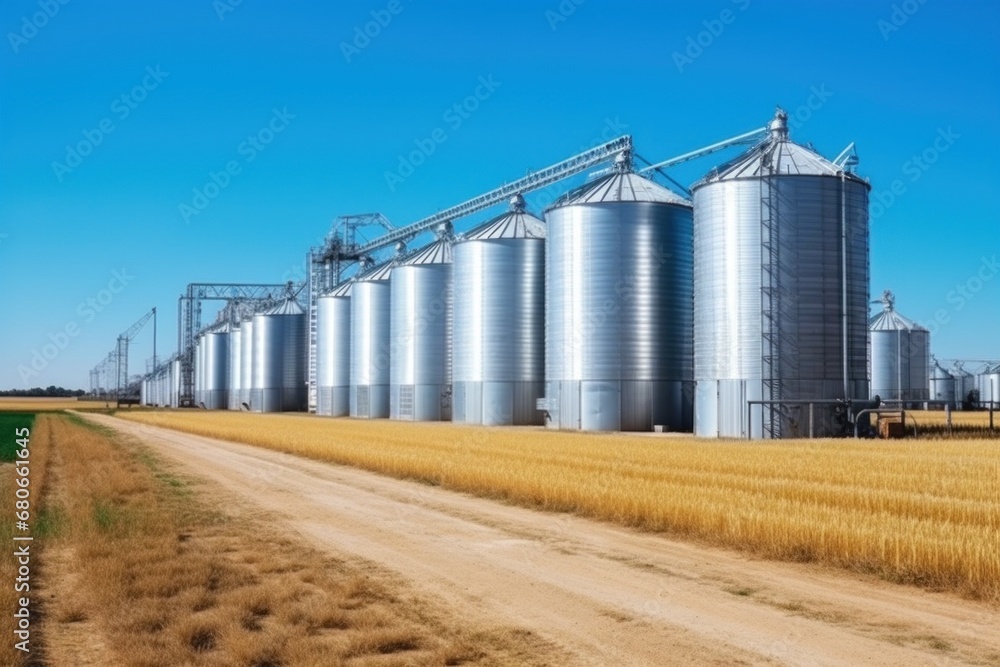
[868,290,931,403]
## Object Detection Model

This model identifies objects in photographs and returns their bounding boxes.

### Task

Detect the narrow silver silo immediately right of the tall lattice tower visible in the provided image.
[316,281,352,417]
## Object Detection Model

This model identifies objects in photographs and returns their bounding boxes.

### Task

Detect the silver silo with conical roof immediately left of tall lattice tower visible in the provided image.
[250,298,308,412]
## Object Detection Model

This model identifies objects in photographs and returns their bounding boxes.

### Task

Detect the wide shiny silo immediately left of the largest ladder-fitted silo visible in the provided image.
[539,160,693,431]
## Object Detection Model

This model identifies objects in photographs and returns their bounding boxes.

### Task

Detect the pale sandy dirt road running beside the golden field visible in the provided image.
[87,416,1000,667]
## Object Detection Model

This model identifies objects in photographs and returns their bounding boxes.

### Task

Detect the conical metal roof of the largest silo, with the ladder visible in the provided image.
[693,109,867,188]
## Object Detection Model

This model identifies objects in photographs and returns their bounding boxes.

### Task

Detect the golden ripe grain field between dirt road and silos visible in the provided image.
[119,412,1000,600]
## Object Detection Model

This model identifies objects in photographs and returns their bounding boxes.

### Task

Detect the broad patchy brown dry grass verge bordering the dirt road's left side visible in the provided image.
[35,416,560,667]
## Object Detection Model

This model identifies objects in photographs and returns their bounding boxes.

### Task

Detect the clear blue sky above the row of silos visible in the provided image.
[0,0,1000,388]
